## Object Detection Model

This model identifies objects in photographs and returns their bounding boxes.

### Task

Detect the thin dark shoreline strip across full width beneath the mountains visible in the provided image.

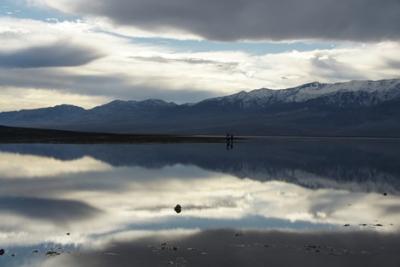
[0,126,400,144]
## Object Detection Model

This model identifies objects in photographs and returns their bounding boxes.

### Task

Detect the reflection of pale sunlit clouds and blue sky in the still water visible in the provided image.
[0,146,400,250]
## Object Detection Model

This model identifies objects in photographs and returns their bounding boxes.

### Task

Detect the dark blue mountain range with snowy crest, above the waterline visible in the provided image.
[0,79,400,137]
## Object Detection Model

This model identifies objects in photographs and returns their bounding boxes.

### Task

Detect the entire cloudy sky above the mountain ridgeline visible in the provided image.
[0,0,400,111]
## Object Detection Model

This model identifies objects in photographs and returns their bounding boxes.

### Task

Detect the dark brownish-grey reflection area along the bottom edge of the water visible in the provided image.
[22,230,400,267]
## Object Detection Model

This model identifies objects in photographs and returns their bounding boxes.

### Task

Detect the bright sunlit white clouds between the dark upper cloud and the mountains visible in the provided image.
[0,17,400,107]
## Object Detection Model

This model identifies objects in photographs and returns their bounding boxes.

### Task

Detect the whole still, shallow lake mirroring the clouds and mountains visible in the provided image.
[0,139,400,267]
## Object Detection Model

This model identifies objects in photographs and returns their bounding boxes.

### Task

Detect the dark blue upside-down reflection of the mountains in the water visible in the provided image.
[0,142,400,195]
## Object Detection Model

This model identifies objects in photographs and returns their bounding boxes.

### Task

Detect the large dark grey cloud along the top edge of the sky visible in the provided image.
[36,0,400,41]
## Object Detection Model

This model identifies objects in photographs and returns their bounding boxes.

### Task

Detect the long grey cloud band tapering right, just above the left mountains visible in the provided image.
[0,69,217,104]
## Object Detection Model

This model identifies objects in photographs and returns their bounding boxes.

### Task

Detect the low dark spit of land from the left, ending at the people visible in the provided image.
[0,126,225,144]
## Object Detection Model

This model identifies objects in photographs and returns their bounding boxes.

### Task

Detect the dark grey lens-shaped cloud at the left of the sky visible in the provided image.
[0,42,102,68]
